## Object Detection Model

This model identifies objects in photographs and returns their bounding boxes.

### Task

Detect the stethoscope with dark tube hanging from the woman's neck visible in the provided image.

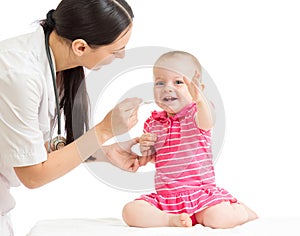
[45,32,66,151]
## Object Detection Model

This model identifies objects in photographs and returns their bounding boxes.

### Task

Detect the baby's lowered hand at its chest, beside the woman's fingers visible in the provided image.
[139,133,157,166]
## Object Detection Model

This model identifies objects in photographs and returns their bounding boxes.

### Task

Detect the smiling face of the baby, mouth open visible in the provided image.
[153,67,192,116]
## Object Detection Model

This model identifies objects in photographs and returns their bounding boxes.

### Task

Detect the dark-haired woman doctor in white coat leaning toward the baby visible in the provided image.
[0,0,141,236]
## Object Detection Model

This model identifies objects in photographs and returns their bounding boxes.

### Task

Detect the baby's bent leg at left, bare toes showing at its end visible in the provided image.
[122,200,192,227]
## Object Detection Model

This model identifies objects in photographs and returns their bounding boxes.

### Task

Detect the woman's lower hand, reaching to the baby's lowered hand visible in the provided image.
[103,138,140,172]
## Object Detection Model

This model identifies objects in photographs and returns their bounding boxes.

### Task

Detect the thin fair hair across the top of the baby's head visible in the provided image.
[154,51,202,81]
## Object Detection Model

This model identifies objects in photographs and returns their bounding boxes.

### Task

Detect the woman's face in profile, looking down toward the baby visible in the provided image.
[83,25,132,70]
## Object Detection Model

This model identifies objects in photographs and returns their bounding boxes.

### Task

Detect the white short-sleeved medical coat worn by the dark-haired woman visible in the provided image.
[0,26,55,216]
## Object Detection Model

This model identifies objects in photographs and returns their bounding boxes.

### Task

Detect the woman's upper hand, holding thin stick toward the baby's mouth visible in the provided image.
[97,98,142,138]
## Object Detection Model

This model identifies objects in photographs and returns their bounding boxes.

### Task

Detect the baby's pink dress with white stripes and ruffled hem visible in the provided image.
[138,103,237,224]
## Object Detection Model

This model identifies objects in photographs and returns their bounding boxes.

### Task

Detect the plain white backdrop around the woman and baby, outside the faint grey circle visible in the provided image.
[0,0,300,236]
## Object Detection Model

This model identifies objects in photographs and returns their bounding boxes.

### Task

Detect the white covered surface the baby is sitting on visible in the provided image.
[26,218,300,236]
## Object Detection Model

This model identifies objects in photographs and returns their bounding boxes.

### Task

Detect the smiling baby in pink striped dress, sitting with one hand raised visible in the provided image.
[123,51,257,228]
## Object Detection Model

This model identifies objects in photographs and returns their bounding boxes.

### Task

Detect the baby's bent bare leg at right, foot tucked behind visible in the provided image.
[195,202,257,228]
